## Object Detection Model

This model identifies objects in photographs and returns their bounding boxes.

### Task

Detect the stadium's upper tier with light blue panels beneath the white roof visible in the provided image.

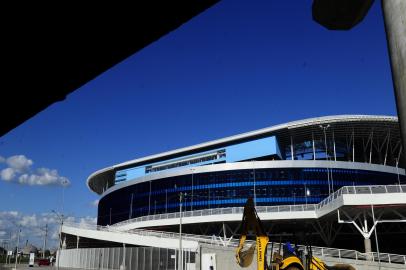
[87,115,405,194]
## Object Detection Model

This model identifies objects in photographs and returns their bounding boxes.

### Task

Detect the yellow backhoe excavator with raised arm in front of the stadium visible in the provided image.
[236,198,355,270]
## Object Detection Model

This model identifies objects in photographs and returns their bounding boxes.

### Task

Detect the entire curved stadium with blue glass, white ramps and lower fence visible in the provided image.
[58,115,406,269]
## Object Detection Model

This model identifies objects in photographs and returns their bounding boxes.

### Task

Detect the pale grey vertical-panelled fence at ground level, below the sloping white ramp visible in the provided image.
[55,247,196,270]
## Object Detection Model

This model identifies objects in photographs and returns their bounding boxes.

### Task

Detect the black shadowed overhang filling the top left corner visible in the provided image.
[0,0,219,136]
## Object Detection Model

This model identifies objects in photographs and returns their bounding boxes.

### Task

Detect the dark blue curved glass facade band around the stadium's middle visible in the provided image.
[98,168,406,225]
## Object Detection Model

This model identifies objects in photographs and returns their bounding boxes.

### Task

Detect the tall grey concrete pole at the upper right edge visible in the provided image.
[382,0,406,168]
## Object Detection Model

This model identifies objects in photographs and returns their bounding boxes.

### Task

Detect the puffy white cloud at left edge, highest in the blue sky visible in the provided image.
[0,155,71,186]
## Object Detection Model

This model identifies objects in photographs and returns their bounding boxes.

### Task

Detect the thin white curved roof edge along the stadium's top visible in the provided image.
[86,114,398,193]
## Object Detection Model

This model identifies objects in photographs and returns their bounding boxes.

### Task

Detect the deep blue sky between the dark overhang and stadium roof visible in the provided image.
[0,0,396,249]
